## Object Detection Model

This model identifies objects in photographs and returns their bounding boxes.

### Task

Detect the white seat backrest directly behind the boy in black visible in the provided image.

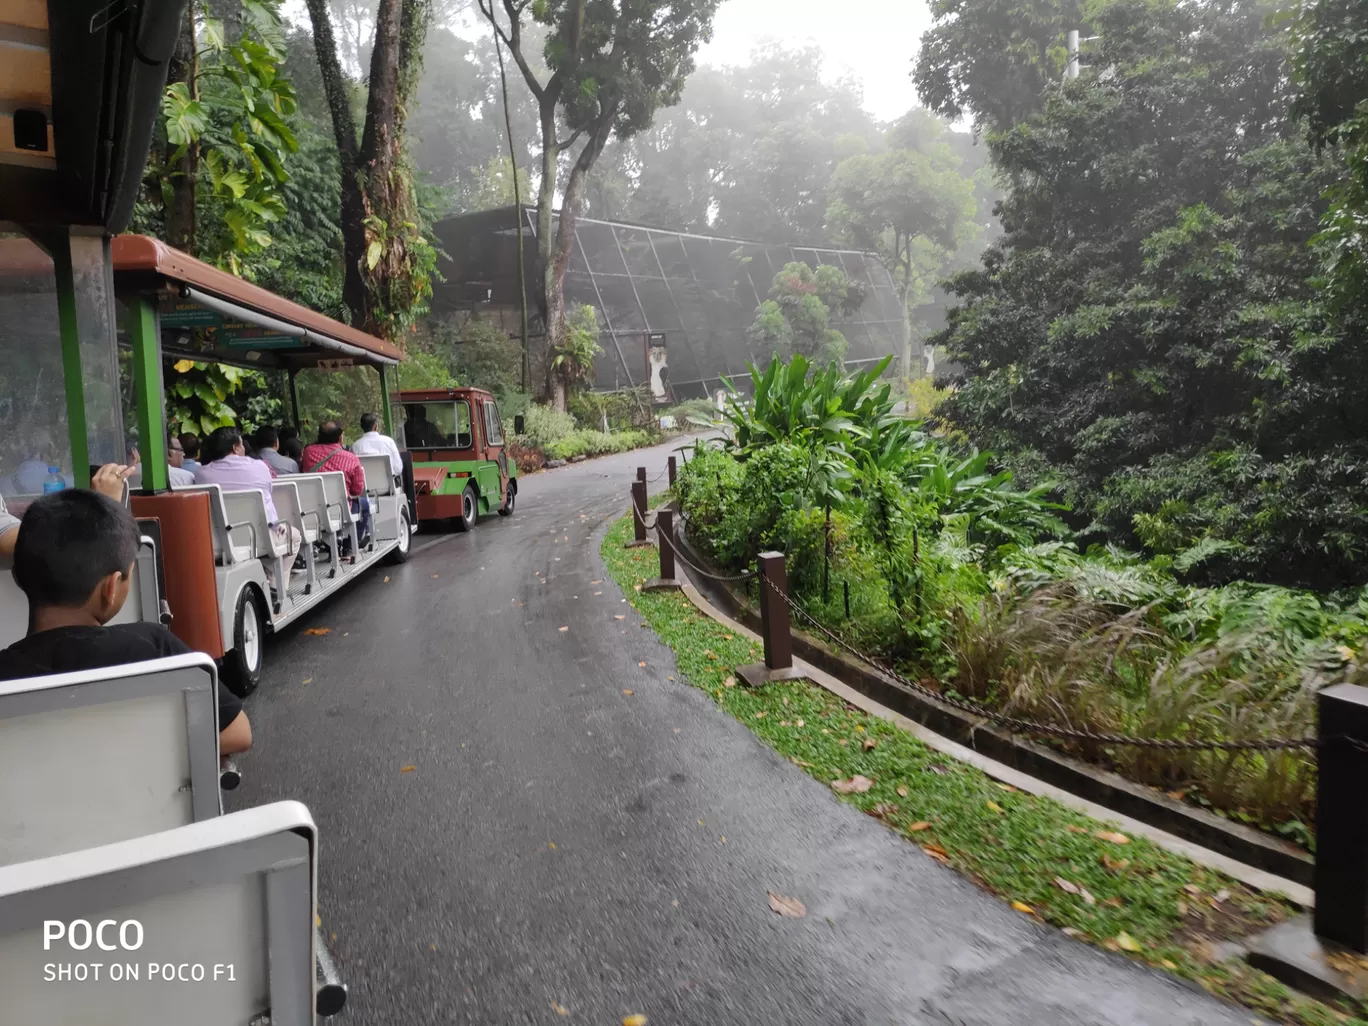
[0,653,222,870]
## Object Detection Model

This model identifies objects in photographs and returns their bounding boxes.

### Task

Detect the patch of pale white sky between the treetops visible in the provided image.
[698,0,932,120]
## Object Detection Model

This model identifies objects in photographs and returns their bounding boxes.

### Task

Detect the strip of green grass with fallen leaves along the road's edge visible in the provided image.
[602,517,1368,1026]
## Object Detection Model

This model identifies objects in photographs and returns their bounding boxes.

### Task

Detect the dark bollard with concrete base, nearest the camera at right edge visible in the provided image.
[1245,684,1368,1000]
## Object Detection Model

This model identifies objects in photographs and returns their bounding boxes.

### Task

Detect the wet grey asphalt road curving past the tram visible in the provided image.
[231,447,1250,1026]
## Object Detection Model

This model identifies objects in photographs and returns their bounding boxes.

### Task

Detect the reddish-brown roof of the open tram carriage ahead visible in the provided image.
[112,235,404,369]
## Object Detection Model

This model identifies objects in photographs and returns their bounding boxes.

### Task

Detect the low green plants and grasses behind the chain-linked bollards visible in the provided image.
[677,357,1368,840]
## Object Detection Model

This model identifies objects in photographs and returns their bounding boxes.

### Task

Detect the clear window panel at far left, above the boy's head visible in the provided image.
[0,235,75,512]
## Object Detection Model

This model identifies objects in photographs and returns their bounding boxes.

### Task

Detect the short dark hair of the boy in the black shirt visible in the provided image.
[14,488,140,609]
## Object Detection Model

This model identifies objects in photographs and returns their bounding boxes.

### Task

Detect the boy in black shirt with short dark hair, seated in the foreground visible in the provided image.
[0,489,252,755]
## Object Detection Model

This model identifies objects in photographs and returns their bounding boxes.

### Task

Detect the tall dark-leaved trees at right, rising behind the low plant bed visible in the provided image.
[918,0,1368,590]
